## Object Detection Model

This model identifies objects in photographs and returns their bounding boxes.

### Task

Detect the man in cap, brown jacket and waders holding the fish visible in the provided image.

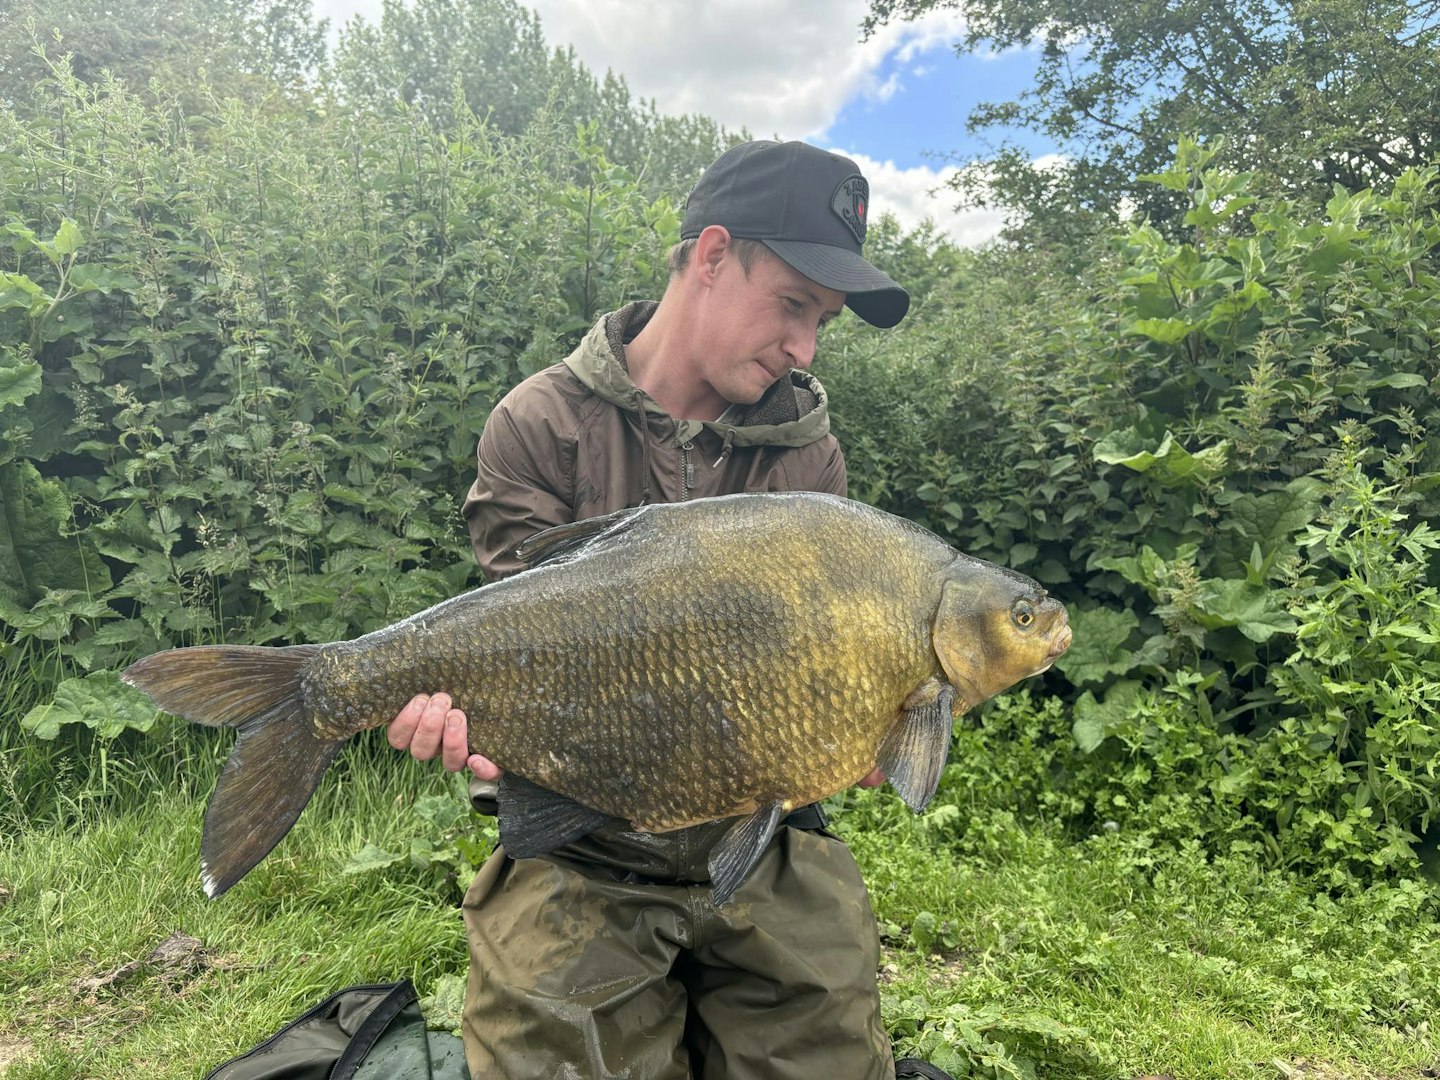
[389,141,910,1080]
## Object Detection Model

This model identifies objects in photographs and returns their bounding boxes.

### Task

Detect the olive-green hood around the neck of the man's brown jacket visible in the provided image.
[564,301,829,446]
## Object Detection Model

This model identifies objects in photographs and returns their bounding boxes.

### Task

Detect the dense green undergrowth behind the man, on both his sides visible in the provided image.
[0,71,1440,881]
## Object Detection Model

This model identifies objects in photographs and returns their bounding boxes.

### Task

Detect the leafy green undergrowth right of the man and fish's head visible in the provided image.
[821,140,1440,883]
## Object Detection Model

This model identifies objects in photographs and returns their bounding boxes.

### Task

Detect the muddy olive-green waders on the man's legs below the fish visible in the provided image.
[464,822,894,1080]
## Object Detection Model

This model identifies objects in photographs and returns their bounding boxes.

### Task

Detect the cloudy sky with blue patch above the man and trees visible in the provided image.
[312,0,1054,245]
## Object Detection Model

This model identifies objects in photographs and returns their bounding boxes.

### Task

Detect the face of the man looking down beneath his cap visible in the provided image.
[701,243,845,405]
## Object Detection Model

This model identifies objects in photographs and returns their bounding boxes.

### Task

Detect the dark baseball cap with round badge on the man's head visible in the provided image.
[680,140,910,327]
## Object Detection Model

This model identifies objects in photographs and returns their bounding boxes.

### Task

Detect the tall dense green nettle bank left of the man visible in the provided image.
[0,63,678,671]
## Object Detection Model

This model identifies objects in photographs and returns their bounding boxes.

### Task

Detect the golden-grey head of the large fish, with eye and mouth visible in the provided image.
[930,554,1070,714]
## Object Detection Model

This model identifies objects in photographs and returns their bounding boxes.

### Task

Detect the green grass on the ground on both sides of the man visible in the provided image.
[0,714,1440,1080]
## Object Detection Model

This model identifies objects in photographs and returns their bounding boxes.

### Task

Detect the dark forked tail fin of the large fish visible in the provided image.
[121,645,344,897]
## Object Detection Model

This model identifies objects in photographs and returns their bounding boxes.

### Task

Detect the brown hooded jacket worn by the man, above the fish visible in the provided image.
[464,302,845,579]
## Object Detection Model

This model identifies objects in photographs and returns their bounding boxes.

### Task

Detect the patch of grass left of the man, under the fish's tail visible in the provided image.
[0,736,465,1080]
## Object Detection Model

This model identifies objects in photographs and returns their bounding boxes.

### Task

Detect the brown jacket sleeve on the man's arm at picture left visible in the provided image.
[461,397,575,580]
